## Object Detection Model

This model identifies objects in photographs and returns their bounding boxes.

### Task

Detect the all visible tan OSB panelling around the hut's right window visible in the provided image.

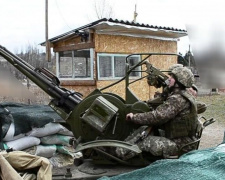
[95,34,177,100]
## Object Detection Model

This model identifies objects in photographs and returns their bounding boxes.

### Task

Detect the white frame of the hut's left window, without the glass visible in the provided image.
[56,48,94,81]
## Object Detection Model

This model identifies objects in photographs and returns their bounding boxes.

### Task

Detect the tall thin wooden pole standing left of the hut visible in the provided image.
[45,0,51,62]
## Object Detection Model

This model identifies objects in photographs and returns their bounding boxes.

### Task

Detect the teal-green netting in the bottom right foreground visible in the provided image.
[100,144,225,180]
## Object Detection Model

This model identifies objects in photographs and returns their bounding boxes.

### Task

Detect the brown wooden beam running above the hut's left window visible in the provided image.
[53,42,95,52]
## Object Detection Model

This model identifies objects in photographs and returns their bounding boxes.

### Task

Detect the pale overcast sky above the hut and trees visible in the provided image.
[0,0,225,87]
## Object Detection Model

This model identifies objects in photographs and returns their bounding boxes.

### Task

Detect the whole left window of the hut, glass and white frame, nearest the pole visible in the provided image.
[57,49,93,80]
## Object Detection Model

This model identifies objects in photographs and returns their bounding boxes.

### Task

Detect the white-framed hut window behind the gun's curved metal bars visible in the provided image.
[98,53,141,80]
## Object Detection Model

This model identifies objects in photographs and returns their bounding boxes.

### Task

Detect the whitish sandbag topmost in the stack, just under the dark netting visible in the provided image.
[26,123,63,137]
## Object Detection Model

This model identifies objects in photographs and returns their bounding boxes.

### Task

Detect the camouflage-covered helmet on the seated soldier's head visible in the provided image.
[171,67,194,88]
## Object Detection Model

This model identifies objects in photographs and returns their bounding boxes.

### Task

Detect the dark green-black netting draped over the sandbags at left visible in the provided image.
[0,102,62,136]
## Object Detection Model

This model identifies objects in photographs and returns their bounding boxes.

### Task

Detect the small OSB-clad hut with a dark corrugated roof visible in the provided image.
[41,18,187,100]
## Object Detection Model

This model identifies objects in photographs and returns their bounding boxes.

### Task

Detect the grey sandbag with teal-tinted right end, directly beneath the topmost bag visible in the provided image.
[40,134,73,146]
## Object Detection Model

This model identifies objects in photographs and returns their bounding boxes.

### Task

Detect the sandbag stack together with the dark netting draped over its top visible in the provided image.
[0,103,81,166]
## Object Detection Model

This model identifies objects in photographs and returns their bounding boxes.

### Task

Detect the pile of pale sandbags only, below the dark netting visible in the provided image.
[3,122,73,158]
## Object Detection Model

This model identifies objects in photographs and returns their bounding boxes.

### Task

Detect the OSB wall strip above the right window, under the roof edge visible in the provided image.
[95,34,177,54]
